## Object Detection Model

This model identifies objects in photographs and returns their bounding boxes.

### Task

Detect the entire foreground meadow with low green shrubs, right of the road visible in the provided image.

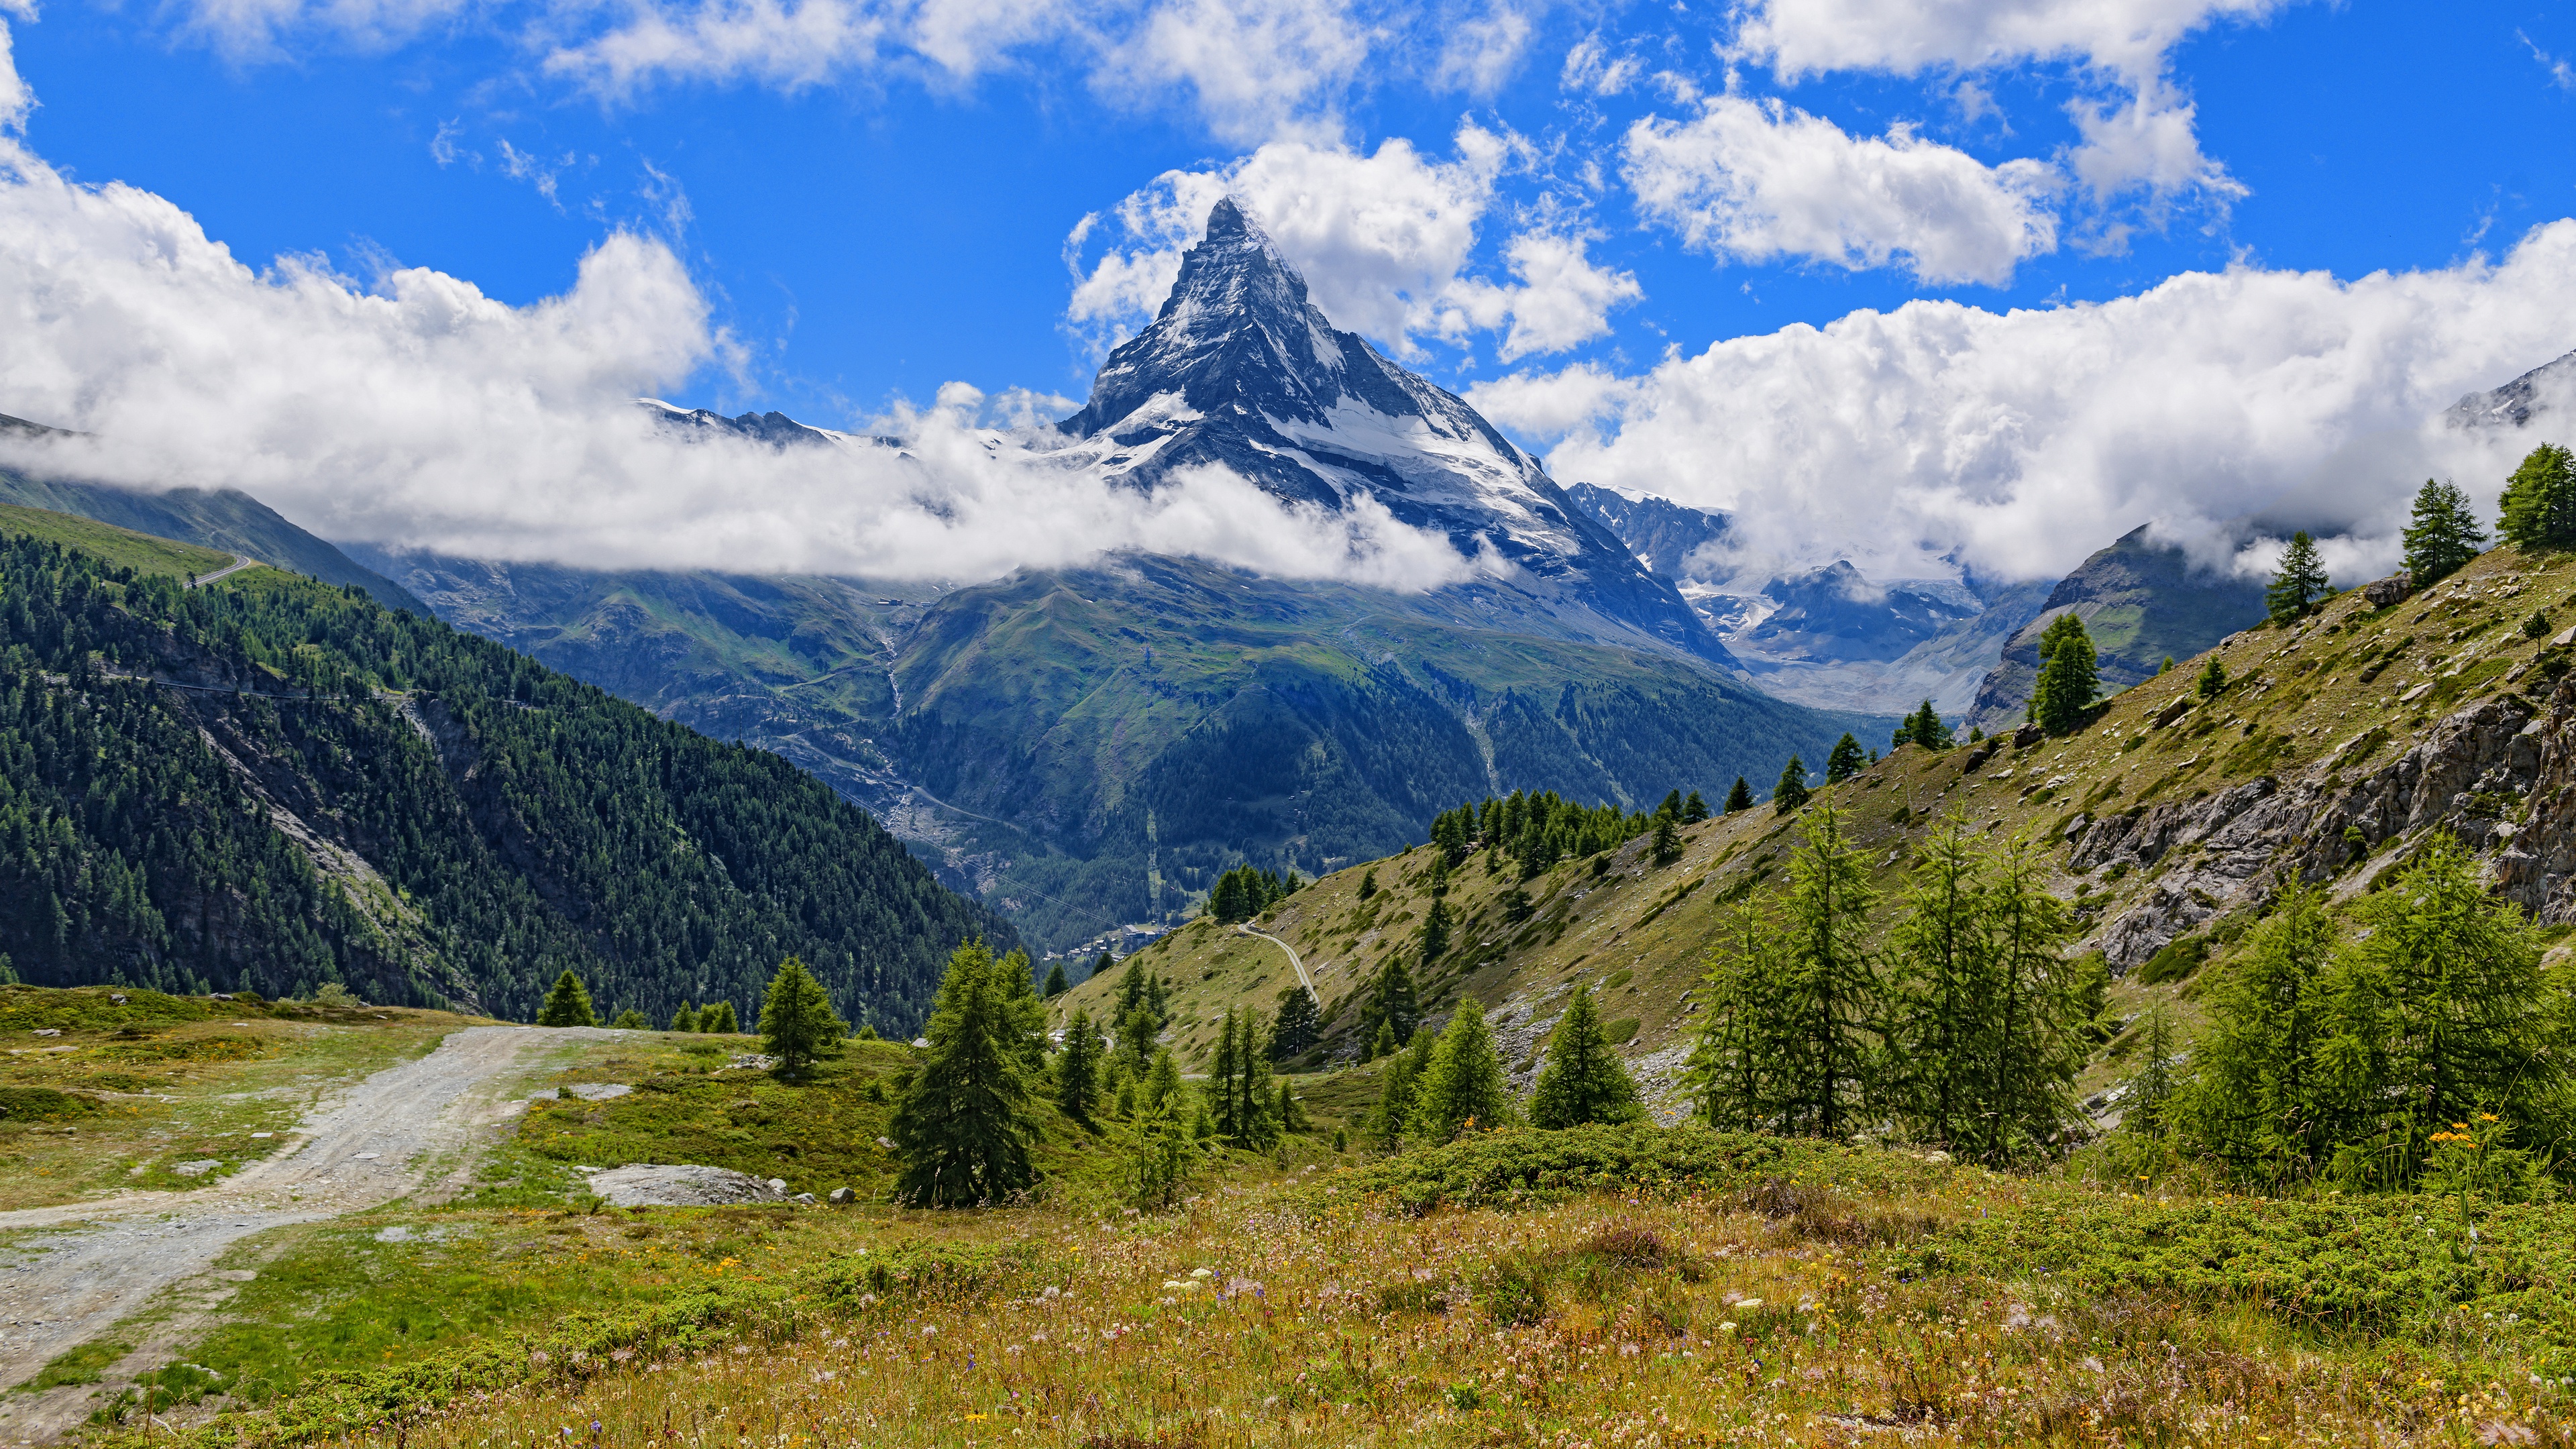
[156,1129,2576,1449]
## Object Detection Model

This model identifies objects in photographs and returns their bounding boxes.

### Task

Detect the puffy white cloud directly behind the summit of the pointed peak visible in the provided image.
[1067,126,1644,358]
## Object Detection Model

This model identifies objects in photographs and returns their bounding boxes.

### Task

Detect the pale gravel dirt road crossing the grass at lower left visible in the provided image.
[0,1026,610,1444]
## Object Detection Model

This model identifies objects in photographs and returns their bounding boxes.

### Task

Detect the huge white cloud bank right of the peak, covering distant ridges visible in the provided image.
[1473,219,2576,583]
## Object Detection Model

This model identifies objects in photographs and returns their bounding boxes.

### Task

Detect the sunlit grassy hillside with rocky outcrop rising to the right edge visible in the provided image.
[1081,536,2576,1106]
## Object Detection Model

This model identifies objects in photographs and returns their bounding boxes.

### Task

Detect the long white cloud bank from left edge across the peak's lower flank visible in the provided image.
[0,49,1479,588]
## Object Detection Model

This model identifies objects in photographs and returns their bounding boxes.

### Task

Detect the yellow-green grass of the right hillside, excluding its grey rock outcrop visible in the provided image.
[1056,536,2576,1095]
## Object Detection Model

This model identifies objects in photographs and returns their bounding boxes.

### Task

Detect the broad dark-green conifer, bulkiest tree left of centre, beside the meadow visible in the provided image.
[886,941,1038,1207]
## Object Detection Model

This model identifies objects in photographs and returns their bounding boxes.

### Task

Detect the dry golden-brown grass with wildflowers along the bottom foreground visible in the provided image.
[332,1173,2576,1449]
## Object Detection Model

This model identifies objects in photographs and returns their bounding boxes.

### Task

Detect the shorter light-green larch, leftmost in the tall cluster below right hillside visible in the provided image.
[1682,898,1793,1132]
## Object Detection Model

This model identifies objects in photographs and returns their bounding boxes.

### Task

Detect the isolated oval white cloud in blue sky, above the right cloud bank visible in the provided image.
[1625,95,2058,286]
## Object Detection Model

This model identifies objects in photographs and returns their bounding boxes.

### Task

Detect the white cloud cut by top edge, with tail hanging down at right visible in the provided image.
[1729,0,2298,206]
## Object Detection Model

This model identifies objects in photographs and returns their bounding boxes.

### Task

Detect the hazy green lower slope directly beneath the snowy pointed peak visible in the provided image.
[363,543,1891,947]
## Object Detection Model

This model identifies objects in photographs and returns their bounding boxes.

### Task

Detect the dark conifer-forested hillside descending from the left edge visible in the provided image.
[0,515,1015,1031]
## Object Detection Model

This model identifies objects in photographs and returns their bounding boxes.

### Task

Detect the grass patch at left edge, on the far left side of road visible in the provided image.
[0,987,469,1210]
